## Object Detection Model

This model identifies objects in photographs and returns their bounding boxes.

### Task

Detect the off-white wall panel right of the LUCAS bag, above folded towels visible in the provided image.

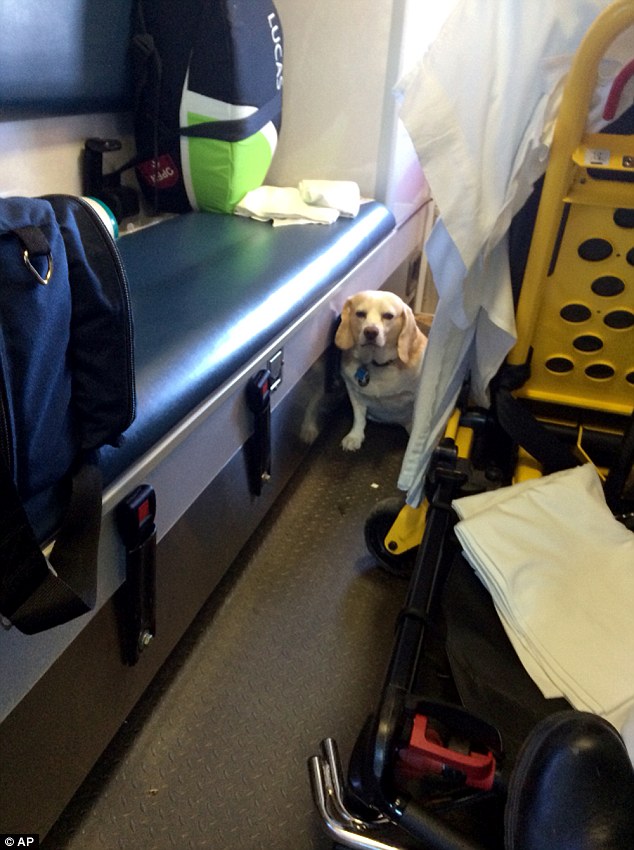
[267,0,392,196]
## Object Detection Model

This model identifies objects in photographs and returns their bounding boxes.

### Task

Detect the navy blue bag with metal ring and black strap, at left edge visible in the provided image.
[0,195,136,634]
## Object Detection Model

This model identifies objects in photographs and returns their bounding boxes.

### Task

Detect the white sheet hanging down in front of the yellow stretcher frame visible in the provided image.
[397,0,634,505]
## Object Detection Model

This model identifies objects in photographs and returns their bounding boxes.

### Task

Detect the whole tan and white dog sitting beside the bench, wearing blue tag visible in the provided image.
[335,290,427,451]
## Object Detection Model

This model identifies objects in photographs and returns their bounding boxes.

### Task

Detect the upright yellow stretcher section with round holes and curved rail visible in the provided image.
[507,0,634,416]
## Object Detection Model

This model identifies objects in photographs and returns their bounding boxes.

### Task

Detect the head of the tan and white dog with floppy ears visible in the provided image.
[335,290,426,365]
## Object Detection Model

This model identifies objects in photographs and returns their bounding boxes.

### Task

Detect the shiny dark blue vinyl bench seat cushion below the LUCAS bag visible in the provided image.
[101,202,395,484]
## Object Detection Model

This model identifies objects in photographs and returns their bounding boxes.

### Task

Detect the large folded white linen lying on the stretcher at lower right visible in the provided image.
[454,464,634,728]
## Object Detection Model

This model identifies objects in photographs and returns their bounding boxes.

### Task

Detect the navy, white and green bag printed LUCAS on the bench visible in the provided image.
[133,0,284,212]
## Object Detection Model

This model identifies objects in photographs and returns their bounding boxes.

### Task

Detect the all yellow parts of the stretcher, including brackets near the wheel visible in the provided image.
[384,0,634,557]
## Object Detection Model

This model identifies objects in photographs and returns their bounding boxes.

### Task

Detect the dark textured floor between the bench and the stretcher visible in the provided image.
[42,420,407,850]
